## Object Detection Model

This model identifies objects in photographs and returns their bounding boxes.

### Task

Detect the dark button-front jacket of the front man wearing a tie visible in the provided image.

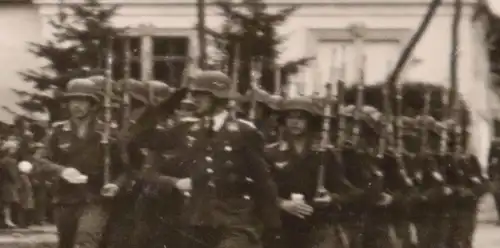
[147,113,280,228]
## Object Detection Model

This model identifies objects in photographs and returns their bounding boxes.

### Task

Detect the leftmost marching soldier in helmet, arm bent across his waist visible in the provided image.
[35,79,139,248]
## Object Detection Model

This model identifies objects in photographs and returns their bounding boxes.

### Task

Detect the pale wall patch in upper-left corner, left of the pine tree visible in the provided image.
[0,4,42,122]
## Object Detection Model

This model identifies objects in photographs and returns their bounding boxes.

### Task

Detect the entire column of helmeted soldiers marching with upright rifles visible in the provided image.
[19,67,488,248]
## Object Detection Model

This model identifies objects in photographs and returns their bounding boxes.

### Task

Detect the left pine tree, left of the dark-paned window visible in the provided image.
[15,0,123,121]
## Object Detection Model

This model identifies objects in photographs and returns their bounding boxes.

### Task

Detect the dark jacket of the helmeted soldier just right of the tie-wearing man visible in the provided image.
[266,138,353,228]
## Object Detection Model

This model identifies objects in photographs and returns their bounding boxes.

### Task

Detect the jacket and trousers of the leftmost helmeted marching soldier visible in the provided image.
[35,121,133,248]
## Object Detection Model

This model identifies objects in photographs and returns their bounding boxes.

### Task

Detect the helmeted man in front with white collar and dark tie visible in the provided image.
[145,71,280,248]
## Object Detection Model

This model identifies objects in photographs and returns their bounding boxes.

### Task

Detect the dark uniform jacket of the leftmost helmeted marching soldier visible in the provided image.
[35,121,136,204]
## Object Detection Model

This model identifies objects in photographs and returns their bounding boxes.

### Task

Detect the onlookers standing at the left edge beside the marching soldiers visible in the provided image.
[0,127,52,229]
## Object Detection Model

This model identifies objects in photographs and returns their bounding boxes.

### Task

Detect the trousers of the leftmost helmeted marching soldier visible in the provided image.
[54,203,108,248]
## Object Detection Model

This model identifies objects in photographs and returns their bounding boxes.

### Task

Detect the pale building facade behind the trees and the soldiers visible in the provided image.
[0,0,492,167]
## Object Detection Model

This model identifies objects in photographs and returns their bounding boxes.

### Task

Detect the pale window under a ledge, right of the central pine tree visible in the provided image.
[306,26,411,93]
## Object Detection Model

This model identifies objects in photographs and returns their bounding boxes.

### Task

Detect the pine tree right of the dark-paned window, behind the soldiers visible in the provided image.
[207,0,311,93]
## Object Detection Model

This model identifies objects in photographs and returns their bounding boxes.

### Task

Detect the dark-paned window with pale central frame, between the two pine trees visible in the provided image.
[112,27,192,87]
